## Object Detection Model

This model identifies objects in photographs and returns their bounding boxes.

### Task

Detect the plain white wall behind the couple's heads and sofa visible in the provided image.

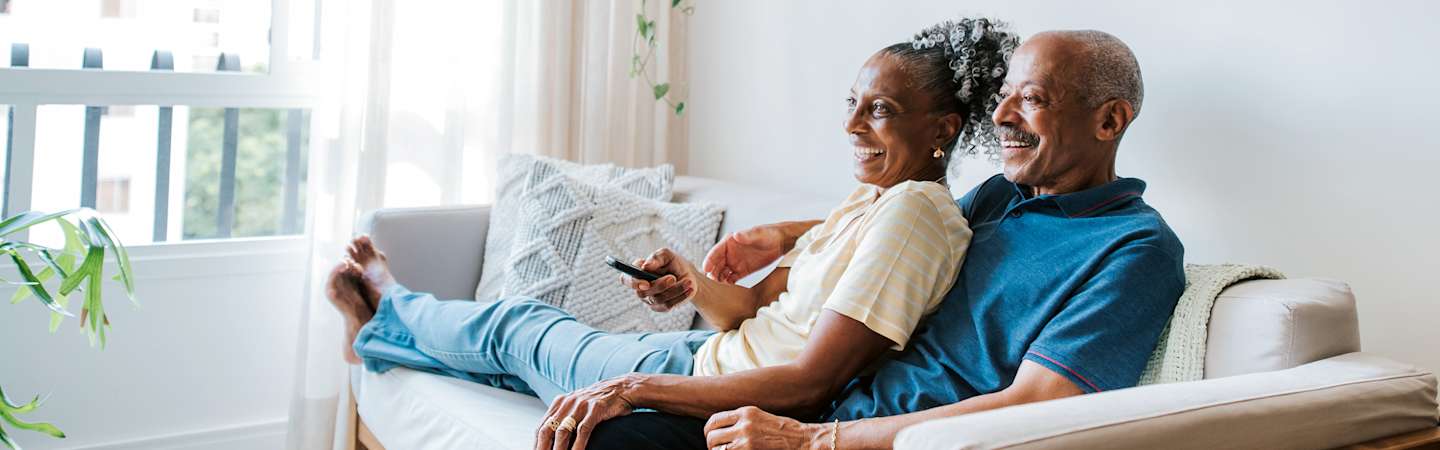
[685,0,1440,372]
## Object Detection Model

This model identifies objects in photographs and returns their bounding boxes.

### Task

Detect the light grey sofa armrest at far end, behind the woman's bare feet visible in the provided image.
[359,205,490,299]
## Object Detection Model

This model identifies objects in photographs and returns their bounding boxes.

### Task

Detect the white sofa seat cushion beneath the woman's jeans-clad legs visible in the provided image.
[351,366,546,450]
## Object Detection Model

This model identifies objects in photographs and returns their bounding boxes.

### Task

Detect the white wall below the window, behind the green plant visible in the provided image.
[0,238,303,449]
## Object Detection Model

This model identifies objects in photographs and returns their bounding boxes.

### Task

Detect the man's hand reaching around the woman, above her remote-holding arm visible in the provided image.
[704,221,818,284]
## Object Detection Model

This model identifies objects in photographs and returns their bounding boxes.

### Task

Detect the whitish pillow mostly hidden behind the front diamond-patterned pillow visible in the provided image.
[475,154,675,301]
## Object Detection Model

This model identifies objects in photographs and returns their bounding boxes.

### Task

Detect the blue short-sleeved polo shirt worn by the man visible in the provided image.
[825,175,1185,421]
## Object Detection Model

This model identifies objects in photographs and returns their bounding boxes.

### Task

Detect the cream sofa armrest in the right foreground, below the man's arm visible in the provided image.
[896,353,1437,449]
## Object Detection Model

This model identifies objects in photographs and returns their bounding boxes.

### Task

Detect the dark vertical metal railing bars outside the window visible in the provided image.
[0,43,305,242]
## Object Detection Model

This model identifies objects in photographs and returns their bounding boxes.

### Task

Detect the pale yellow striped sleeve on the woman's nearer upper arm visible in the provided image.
[824,190,960,350]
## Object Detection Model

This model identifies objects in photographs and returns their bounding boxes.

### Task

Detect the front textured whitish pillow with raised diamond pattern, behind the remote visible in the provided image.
[503,170,724,333]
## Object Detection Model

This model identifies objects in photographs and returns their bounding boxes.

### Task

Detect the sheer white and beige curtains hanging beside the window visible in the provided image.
[288,0,687,449]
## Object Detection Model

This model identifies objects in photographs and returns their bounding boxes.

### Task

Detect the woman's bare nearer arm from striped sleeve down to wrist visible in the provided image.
[619,310,894,417]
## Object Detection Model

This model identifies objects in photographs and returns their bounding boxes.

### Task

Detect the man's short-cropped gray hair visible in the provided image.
[1053,30,1145,115]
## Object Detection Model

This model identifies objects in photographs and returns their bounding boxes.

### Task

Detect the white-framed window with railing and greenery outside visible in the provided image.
[0,0,324,245]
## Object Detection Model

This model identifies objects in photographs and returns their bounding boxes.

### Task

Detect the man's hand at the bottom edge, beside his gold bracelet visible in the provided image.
[706,407,831,450]
